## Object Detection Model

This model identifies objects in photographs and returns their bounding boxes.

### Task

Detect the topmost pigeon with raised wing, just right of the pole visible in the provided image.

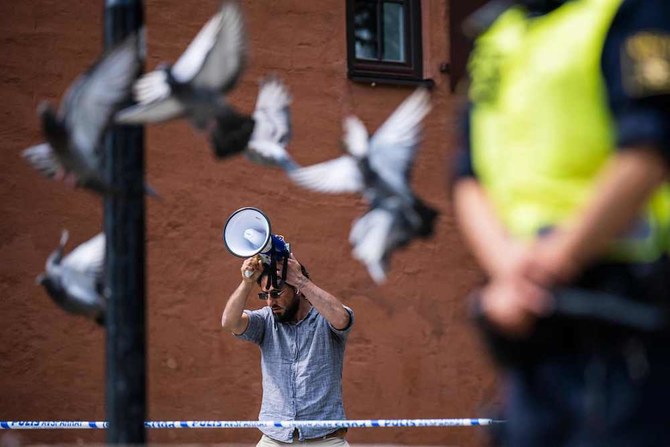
[116,1,253,152]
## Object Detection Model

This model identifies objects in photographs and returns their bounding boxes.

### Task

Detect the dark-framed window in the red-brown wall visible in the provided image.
[347,0,426,84]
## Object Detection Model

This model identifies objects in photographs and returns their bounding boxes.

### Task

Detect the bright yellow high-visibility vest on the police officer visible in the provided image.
[469,0,670,261]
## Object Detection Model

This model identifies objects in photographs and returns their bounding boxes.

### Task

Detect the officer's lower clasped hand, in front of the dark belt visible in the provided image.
[481,277,552,338]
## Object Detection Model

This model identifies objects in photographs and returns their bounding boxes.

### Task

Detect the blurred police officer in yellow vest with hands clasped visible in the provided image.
[453,0,670,447]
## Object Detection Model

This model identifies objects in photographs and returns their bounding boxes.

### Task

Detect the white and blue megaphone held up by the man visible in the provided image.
[223,207,290,282]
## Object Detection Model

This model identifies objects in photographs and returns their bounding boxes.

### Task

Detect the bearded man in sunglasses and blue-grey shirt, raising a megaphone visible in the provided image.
[221,209,353,447]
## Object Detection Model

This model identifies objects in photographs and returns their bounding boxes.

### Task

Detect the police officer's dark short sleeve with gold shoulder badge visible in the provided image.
[602,0,670,163]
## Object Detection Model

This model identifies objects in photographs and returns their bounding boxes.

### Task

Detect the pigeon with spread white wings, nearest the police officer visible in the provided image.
[288,88,437,283]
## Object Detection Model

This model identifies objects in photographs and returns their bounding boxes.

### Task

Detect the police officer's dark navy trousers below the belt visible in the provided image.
[500,340,670,447]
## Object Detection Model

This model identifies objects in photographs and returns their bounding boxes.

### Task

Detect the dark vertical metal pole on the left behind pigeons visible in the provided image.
[104,0,147,444]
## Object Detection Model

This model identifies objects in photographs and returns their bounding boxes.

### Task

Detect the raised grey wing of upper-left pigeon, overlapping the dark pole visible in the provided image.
[60,34,141,166]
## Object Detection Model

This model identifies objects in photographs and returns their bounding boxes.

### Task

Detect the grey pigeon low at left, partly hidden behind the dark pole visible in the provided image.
[36,231,106,325]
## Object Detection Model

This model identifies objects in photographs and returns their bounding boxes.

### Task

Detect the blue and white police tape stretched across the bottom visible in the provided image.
[0,419,504,430]
